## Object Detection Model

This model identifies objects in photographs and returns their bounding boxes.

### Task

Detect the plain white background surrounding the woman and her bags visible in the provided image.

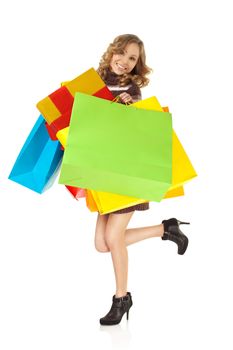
[0,0,233,350]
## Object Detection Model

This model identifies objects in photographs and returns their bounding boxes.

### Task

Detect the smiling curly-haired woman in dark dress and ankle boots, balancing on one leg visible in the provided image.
[95,34,188,325]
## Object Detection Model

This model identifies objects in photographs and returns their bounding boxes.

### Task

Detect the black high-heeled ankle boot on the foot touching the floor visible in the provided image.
[100,292,133,325]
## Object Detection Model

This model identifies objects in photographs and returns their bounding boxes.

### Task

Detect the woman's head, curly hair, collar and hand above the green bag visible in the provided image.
[97,34,152,103]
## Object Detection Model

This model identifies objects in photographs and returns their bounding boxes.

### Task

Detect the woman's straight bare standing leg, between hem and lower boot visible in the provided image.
[105,212,134,298]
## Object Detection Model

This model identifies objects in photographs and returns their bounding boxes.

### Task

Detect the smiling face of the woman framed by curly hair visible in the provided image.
[110,43,139,75]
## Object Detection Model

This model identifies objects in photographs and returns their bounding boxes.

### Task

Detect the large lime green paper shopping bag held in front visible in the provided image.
[59,92,172,201]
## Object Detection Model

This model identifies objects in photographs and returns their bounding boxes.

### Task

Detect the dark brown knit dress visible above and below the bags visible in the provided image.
[103,70,149,214]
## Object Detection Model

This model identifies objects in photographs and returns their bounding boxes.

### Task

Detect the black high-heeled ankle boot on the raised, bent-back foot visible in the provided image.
[161,218,190,255]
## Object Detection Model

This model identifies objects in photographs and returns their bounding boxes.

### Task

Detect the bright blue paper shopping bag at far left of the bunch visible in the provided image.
[8,115,63,193]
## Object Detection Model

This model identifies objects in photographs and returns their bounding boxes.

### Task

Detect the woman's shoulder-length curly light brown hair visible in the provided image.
[97,34,153,88]
